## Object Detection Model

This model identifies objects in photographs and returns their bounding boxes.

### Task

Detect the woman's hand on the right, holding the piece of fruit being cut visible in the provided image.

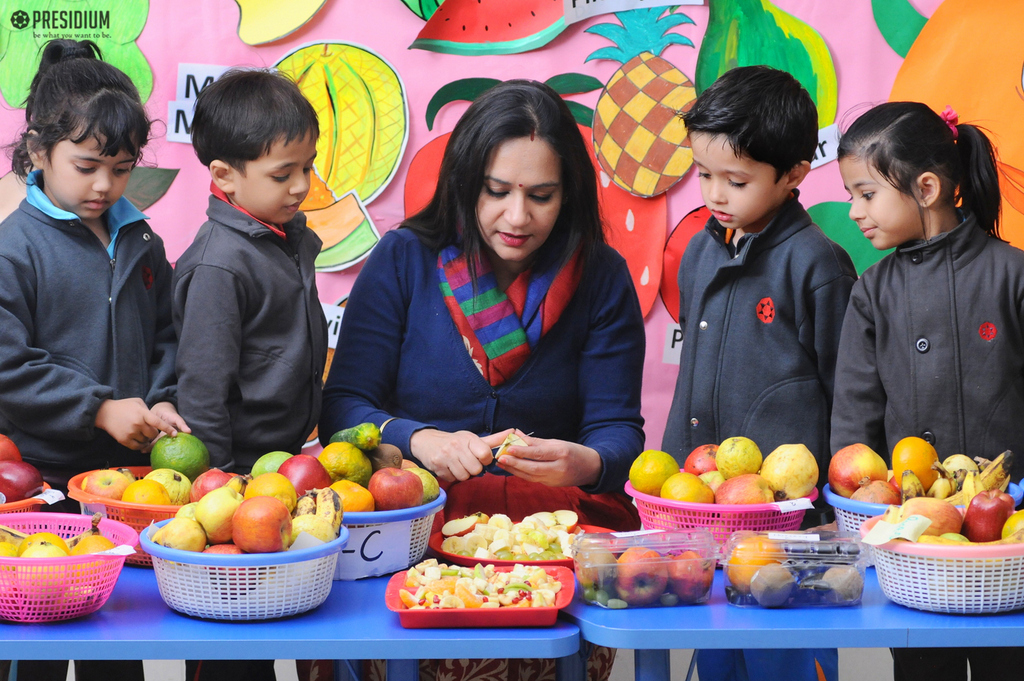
[484,430,603,487]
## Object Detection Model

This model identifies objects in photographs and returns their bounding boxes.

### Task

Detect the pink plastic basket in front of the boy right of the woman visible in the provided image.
[626,482,818,546]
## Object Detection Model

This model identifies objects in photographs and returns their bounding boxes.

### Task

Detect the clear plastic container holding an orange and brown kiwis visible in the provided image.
[722,531,868,607]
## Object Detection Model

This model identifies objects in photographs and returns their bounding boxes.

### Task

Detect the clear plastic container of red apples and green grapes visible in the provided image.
[572,528,718,609]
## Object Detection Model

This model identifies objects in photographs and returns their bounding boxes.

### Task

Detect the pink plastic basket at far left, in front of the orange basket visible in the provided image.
[0,513,138,623]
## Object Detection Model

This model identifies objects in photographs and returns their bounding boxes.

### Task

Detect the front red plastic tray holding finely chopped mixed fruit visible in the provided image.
[384,561,575,629]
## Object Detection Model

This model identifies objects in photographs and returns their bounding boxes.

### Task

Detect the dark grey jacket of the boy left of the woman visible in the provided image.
[173,197,327,472]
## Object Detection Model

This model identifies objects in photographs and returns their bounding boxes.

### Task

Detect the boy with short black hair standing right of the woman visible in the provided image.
[662,67,857,681]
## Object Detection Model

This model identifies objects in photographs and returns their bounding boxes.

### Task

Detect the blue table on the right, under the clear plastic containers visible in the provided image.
[562,568,1024,681]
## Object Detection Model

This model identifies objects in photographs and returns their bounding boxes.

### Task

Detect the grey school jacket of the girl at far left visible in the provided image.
[0,201,175,474]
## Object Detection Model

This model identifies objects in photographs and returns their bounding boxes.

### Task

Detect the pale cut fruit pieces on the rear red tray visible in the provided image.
[441,510,580,561]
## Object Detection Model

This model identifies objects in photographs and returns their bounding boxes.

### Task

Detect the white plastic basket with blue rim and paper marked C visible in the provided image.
[334,490,447,581]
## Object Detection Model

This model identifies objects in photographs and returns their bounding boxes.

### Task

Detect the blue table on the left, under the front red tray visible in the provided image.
[0,566,583,681]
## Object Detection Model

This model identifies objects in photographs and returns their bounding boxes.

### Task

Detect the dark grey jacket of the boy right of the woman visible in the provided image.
[663,199,857,478]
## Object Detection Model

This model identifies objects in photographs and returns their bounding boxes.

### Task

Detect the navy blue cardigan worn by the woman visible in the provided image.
[319,228,645,494]
